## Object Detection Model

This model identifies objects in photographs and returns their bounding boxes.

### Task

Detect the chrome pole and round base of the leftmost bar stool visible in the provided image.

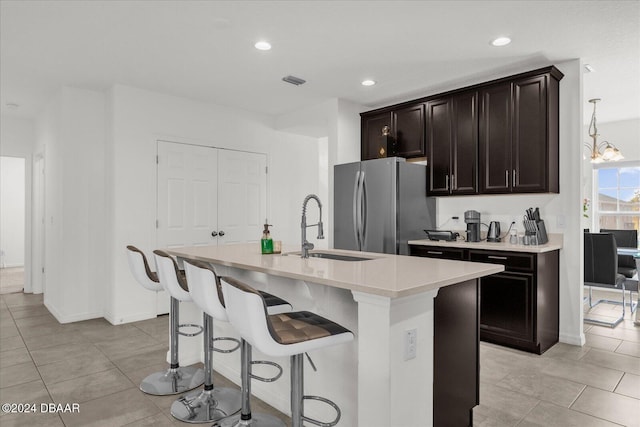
[140,297,204,396]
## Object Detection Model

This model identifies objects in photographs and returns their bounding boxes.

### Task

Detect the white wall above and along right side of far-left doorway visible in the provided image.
[0,115,35,292]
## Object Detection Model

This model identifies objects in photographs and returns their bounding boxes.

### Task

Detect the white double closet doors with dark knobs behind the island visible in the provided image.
[156,141,267,314]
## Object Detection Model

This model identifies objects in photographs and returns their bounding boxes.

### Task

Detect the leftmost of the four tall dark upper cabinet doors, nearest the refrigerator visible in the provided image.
[427,98,451,196]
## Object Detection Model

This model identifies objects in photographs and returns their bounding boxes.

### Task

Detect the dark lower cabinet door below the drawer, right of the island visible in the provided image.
[480,272,534,342]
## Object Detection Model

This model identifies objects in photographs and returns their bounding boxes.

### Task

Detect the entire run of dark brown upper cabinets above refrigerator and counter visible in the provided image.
[361,66,563,196]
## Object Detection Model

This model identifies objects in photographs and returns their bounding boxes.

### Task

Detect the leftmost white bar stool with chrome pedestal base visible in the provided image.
[127,245,204,396]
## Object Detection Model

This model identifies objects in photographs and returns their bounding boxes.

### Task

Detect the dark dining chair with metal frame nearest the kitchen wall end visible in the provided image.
[584,233,625,328]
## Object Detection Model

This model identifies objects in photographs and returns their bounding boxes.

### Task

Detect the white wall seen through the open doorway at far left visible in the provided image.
[0,156,25,267]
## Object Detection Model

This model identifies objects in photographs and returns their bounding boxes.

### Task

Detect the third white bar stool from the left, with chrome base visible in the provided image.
[184,260,292,427]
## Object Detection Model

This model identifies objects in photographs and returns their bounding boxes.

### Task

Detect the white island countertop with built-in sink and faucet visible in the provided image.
[167,243,504,298]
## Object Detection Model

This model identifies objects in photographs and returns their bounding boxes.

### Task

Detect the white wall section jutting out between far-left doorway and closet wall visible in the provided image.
[35,88,107,323]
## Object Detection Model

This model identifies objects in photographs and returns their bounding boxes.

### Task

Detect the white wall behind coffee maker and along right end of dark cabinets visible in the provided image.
[437,60,584,345]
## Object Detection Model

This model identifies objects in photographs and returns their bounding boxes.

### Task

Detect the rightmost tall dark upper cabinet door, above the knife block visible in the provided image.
[511,75,548,193]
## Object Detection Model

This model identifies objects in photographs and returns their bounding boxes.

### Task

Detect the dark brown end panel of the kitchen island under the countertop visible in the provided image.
[432,280,480,427]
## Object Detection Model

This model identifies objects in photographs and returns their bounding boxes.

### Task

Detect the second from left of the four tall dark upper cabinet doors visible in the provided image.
[451,91,478,194]
